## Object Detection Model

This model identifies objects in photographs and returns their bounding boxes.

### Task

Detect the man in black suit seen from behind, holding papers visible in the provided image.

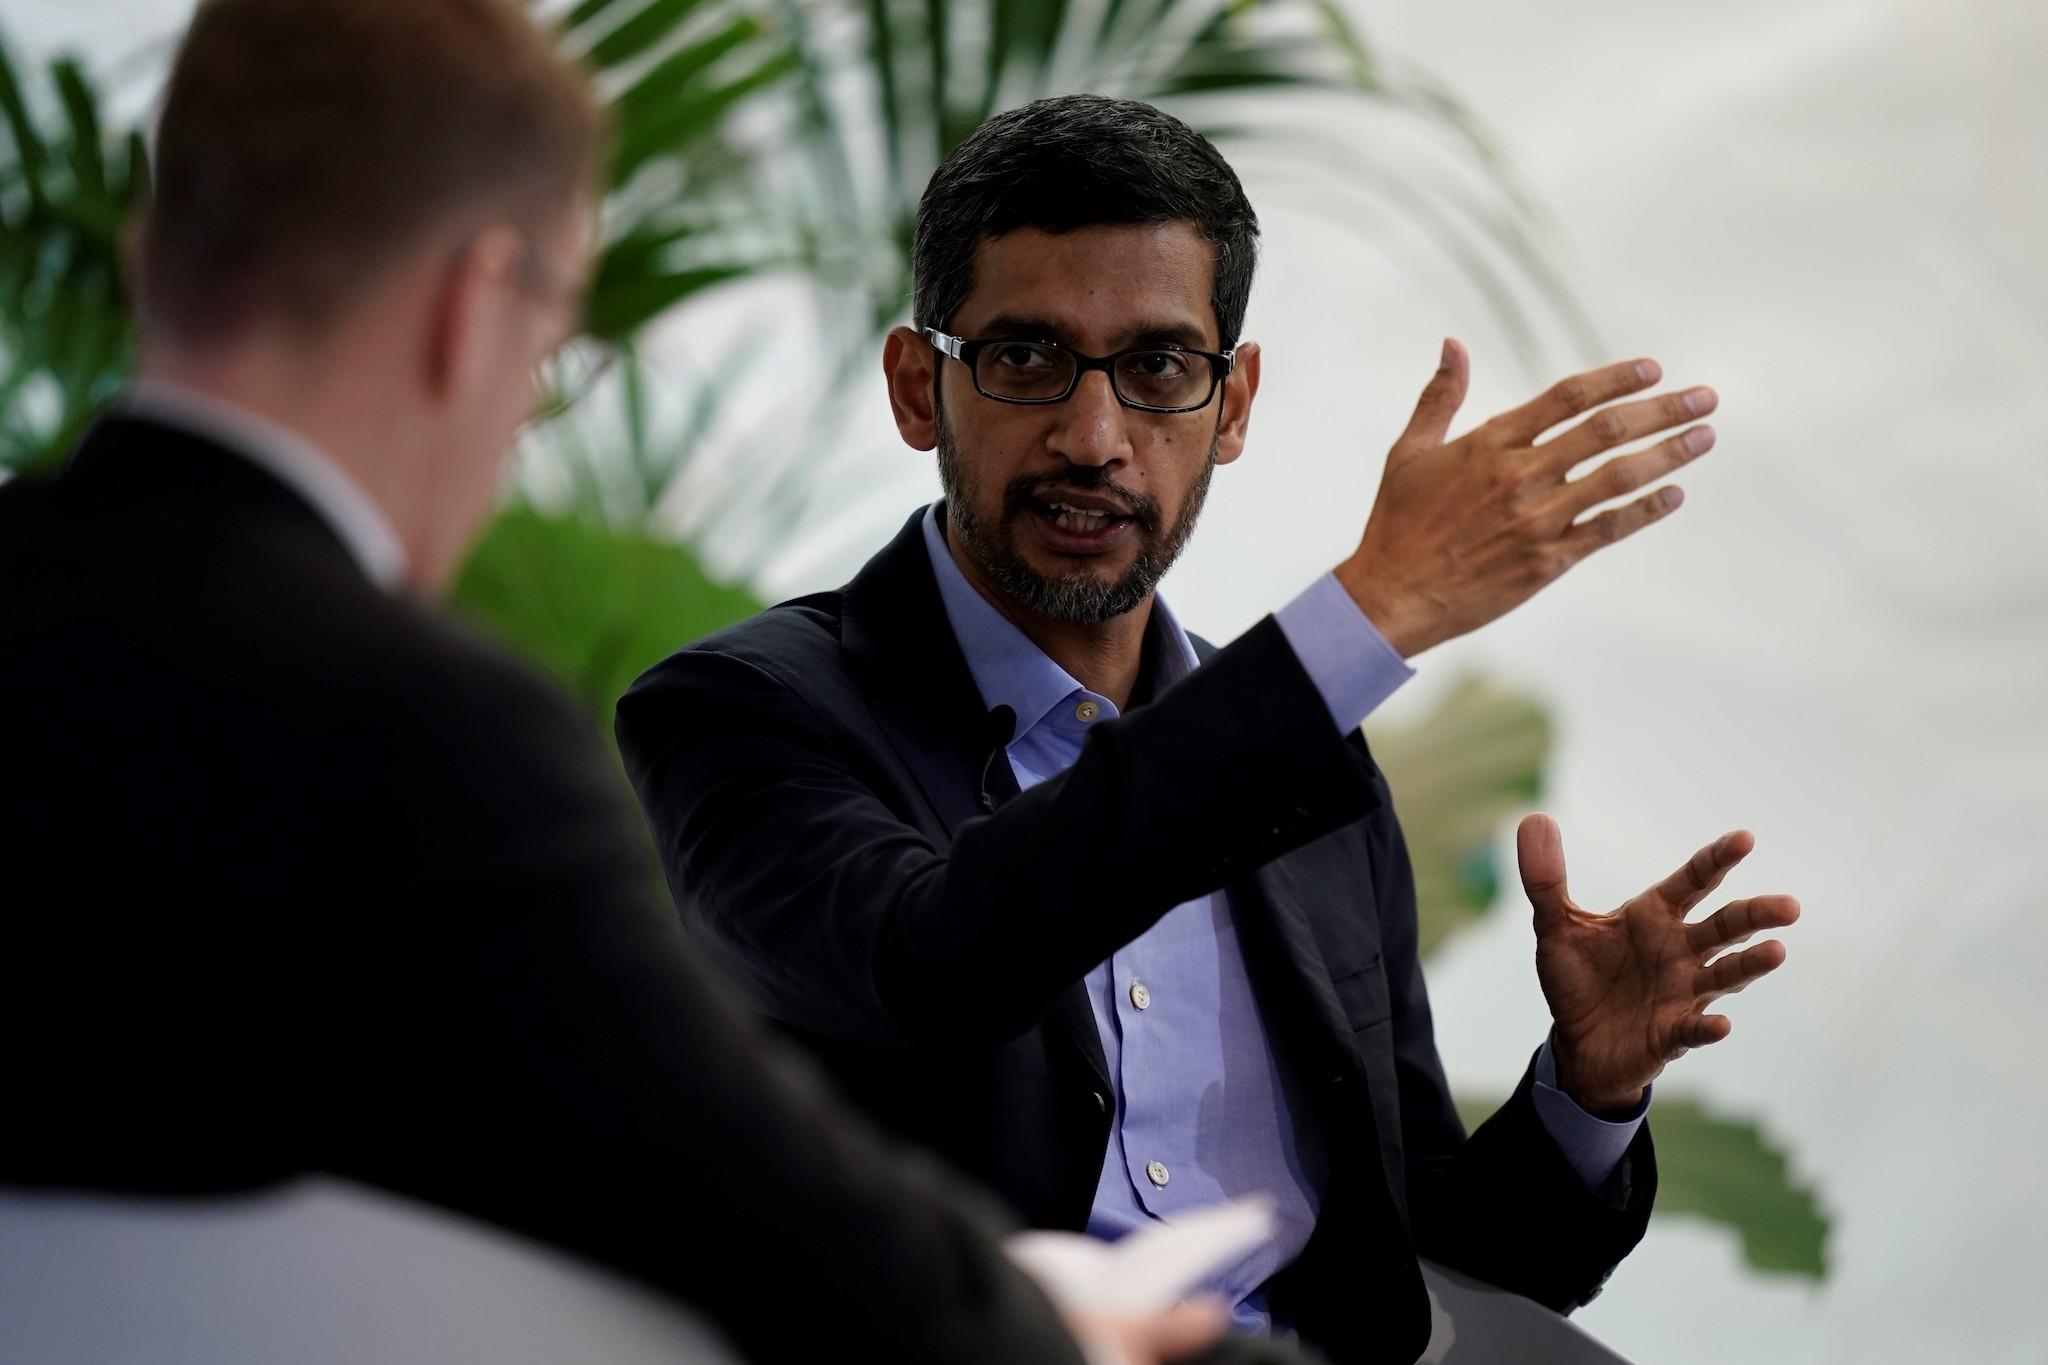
[0,10,1245,1365]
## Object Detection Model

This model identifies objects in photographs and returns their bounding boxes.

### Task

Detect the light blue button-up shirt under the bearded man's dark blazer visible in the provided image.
[924,508,1649,1332]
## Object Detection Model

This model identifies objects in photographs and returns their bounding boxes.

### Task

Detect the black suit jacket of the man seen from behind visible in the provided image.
[0,420,1079,1365]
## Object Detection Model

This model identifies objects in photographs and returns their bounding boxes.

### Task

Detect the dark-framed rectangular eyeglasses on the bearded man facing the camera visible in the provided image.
[922,327,1237,411]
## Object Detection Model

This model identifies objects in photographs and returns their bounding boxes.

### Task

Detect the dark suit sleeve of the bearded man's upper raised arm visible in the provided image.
[618,618,1374,1048]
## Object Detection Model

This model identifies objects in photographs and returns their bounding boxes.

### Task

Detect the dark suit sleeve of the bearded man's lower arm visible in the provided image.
[1372,785,1657,1312]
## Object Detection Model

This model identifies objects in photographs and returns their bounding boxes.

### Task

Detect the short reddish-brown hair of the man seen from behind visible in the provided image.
[139,0,600,346]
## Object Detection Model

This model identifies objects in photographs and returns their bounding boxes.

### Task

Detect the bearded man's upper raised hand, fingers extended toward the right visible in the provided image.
[1337,342,1720,657]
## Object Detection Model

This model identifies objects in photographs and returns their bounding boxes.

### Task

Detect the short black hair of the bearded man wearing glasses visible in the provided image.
[911,94,1260,350]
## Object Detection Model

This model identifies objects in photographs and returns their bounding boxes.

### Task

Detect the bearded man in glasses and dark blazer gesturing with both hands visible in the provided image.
[618,96,1796,1361]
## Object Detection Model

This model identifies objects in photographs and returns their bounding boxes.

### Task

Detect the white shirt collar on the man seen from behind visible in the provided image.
[121,379,406,591]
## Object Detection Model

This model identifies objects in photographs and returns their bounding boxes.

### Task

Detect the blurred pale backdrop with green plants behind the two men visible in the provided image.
[0,0,2048,1365]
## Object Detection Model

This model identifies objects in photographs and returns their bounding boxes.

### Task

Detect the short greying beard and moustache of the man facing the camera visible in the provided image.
[936,392,1221,626]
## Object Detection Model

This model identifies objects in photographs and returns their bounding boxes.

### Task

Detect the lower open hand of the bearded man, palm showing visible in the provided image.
[1518,814,1798,1113]
